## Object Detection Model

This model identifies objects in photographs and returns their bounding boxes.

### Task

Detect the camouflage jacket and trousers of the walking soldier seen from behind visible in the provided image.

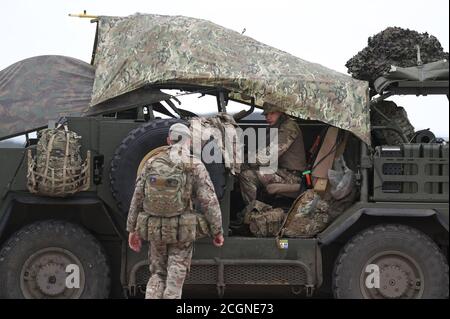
[127,148,223,299]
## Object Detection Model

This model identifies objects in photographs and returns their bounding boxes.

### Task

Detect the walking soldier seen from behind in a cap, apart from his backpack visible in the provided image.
[127,123,224,299]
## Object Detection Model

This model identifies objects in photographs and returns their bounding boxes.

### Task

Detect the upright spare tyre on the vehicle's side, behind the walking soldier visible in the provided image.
[110,119,226,215]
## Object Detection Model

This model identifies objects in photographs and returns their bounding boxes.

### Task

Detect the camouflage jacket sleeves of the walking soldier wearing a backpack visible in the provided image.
[127,148,223,236]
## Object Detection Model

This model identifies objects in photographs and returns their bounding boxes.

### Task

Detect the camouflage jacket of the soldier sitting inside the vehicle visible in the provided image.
[258,114,306,171]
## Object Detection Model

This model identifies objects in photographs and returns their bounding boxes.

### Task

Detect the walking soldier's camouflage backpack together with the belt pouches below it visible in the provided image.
[136,147,209,244]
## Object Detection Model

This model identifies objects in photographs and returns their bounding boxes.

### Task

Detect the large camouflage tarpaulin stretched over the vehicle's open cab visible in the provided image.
[91,14,370,143]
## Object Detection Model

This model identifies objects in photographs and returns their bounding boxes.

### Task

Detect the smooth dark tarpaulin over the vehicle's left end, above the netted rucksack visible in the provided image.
[0,55,94,139]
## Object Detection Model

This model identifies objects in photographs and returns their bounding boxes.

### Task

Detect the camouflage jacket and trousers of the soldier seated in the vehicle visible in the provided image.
[239,114,306,204]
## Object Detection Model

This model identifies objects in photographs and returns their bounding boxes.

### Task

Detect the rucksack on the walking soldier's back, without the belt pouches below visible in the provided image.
[144,152,192,217]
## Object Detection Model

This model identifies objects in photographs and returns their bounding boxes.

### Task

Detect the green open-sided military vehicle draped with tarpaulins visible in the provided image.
[0,15,449,299]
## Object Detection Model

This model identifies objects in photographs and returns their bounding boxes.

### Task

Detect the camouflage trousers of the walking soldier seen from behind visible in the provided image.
[145,242,194,299]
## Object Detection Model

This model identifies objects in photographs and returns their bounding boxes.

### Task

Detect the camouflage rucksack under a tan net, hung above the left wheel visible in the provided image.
[27,124,90,197]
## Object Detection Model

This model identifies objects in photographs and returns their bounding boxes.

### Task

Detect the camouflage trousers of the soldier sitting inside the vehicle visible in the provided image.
[239,168,300,205]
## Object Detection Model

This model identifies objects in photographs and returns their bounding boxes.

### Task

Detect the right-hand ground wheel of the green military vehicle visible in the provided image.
[333,225,448,299]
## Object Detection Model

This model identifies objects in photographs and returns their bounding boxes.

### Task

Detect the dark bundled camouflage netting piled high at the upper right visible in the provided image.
[345,27,448,84]
